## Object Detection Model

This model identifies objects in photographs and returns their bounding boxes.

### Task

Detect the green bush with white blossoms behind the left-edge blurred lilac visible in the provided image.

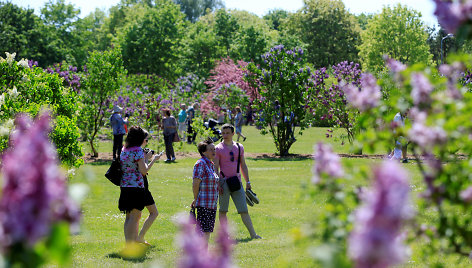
[0,53,83,167]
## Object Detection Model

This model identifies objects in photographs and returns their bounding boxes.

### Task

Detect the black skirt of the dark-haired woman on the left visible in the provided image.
[118,187,155,213]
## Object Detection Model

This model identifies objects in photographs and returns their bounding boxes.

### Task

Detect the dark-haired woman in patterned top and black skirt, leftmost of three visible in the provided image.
[118,126,160,246]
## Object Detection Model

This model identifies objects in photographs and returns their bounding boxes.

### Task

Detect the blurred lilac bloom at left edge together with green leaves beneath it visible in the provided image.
[0,111,80,267]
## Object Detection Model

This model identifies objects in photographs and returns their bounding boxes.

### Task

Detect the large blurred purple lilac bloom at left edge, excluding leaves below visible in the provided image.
[0,114,80,250]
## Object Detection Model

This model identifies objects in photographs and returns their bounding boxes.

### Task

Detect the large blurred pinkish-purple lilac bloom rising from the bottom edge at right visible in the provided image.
[348,161,413,268]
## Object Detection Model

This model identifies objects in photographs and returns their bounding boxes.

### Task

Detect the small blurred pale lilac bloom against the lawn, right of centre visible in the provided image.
[311,142,344,184]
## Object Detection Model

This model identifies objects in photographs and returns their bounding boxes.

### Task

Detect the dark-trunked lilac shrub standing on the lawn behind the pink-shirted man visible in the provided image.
[246,45,313,156]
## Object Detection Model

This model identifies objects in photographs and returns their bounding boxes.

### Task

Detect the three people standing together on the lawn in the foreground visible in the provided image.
[118,121,261,245]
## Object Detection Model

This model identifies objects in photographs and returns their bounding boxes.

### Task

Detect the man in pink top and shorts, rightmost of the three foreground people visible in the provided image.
[214,124,261,239]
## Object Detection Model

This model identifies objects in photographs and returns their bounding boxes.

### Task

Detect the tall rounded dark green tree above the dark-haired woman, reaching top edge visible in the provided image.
[120,0,185,79]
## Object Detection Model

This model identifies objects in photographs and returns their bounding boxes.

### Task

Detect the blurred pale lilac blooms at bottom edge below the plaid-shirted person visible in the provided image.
[177,214,235,268]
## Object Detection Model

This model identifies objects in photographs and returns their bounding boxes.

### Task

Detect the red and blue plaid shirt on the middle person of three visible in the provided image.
[193,157,220,210]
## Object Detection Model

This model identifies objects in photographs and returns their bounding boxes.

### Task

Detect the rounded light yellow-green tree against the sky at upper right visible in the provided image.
[359,4,432,72]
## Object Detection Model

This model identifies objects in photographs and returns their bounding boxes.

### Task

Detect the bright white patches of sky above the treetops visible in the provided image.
[11,0,437,26]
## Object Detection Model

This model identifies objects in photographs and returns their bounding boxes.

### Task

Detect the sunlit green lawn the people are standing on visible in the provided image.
[71,127,472,267]
